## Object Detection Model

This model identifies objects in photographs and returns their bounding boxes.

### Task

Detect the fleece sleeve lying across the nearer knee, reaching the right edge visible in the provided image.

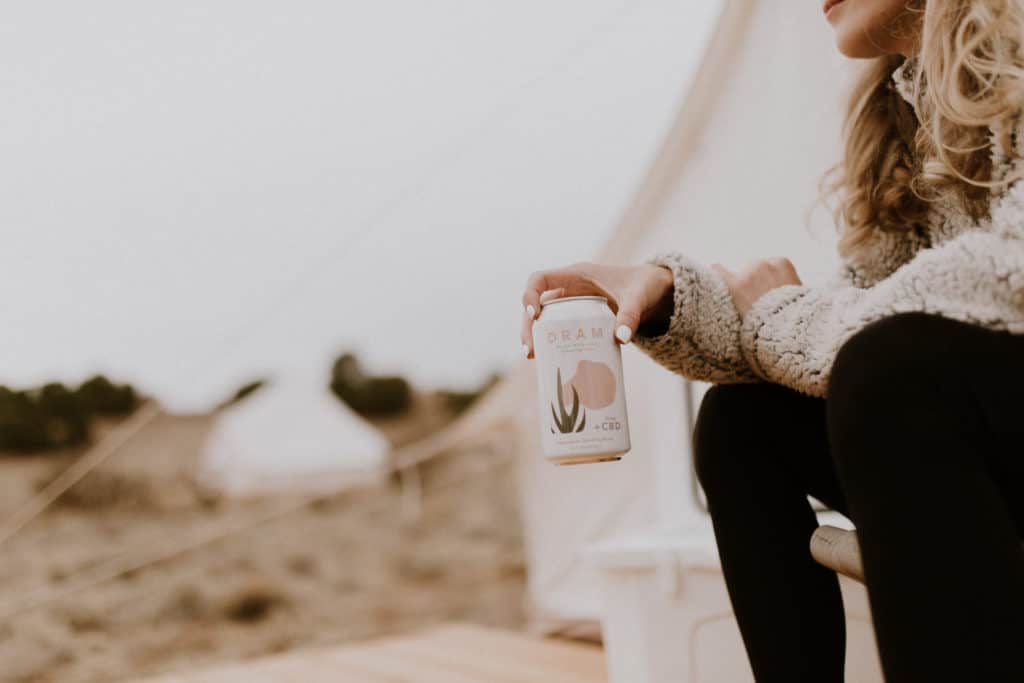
[740,197,1024,396]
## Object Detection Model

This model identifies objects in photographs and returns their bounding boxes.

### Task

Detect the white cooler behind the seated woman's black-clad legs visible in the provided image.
[588,512,884,683]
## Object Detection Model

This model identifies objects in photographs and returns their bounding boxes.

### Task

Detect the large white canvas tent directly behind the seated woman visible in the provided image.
[395,0,872,681]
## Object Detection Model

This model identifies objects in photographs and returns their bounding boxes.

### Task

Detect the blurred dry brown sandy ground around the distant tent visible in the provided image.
[0,395,524,683]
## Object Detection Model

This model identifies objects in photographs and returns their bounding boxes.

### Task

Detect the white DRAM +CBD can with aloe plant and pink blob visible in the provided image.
[534,296,630,465]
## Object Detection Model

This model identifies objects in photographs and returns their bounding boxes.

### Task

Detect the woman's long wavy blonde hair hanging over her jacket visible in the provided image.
[827,0,1024,257]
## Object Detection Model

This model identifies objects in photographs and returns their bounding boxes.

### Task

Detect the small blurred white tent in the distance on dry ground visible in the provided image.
[198,379,390,496]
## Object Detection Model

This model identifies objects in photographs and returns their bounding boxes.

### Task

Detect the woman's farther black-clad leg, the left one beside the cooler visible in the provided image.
[694,384,846,683]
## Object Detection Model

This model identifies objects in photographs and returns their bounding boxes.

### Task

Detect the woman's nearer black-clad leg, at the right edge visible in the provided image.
[827,314,1024,683]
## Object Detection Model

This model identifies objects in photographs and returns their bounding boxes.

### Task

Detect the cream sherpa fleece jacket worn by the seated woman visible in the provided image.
[633,61,1024,396]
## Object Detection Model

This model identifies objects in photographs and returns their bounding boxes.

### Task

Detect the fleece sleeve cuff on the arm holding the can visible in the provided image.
[633,251,759,384]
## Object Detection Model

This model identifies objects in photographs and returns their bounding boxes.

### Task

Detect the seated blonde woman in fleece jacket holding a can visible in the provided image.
[522,0,1024,683]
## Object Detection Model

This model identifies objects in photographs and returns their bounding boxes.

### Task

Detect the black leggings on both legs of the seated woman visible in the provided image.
[694,313,1024,683]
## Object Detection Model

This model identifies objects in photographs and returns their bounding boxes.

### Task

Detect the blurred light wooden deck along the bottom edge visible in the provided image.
[132,624,607,683]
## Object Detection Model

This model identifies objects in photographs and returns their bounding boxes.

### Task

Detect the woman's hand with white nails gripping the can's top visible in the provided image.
[521,262,674,358]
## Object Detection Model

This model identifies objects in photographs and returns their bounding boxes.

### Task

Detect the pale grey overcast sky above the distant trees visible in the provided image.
[0,0,718,411]
